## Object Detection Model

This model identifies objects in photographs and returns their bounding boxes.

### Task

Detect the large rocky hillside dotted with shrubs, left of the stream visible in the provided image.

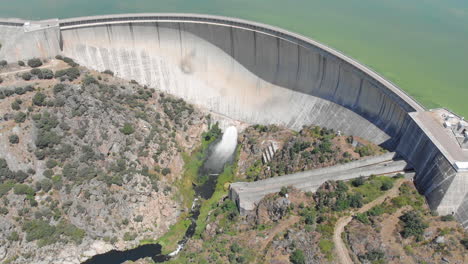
[0,57,207,263]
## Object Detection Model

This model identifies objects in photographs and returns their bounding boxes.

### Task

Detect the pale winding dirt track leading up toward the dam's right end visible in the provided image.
[333,179,405,264]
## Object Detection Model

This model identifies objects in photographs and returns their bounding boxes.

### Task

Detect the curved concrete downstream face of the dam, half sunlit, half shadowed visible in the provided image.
[56,17,422,149]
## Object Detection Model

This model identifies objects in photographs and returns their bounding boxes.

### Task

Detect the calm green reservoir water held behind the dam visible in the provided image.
[0,0,468,116]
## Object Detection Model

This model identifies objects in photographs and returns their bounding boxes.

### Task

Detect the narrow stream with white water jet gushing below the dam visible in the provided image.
[82,127,237,264]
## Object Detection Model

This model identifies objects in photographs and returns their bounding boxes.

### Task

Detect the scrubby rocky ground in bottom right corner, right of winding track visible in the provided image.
[346,183,468,264]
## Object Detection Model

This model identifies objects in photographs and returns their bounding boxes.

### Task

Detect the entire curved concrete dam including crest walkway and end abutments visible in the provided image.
[0,14,468,227]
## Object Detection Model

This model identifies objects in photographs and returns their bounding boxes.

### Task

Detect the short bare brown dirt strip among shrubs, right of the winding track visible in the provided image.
[380,207,415,264]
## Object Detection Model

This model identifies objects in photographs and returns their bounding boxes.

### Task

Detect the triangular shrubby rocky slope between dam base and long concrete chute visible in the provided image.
[237,125,385,181]
